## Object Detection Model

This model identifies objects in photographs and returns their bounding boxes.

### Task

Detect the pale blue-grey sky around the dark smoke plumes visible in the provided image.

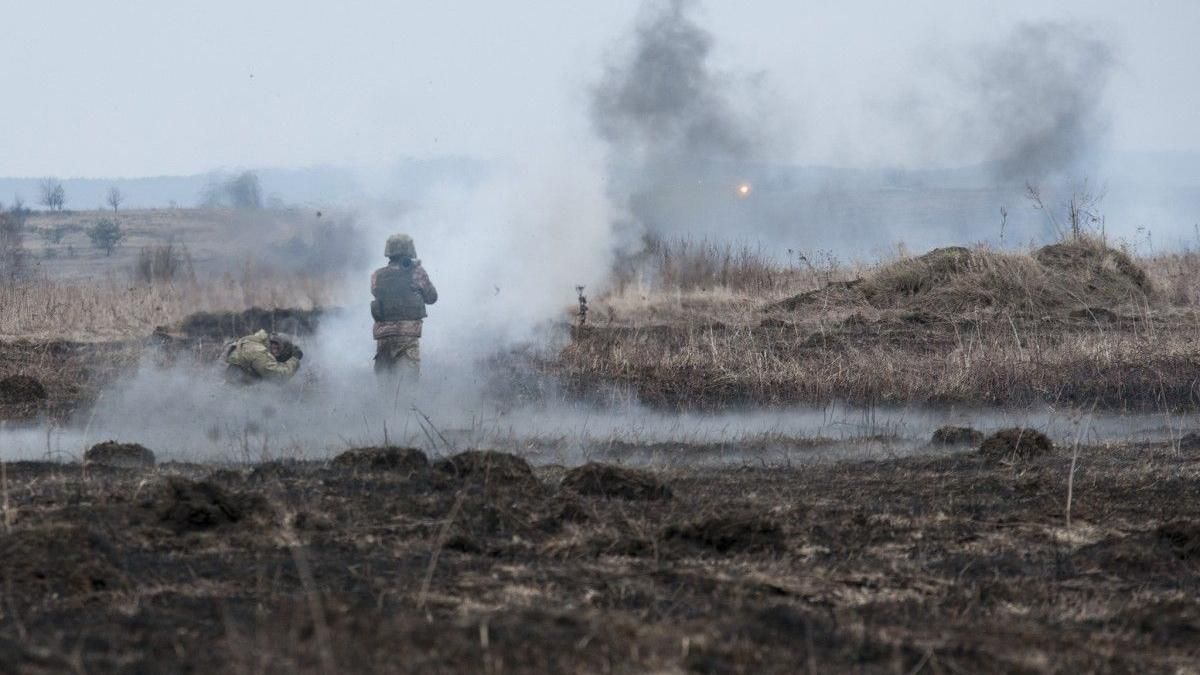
[0,0,1200,177]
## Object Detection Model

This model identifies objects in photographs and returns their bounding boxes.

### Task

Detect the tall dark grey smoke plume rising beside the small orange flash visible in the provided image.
[590,0,768,253]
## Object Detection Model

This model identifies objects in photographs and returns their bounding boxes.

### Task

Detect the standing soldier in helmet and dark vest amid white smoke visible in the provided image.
[371,234,438,380]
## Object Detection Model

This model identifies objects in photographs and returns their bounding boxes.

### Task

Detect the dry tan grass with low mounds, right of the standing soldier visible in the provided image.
[566,234,1200,410]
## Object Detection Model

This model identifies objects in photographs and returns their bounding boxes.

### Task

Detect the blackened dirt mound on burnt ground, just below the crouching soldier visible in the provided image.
[143,477,268,533]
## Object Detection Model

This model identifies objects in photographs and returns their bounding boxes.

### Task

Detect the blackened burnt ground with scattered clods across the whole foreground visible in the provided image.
[0,444,1200,673]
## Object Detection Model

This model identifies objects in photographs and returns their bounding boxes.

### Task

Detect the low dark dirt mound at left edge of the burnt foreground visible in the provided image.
[0,525,128,598]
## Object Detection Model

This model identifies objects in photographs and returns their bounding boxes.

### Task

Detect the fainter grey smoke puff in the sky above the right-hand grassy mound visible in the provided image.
[965,23,1116,183]
